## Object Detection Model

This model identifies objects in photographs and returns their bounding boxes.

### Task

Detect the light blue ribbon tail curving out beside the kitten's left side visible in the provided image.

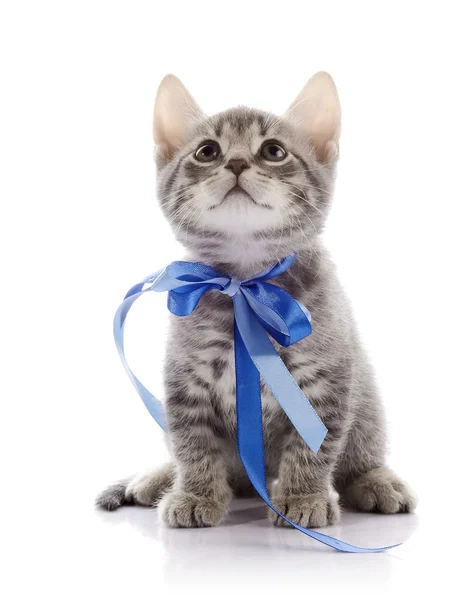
[114,289,167,431]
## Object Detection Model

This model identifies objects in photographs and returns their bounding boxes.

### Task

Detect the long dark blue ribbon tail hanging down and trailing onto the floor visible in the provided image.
[234,321,395,554]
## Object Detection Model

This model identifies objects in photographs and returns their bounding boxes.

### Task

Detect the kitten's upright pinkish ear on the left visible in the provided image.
[153,75,203,160]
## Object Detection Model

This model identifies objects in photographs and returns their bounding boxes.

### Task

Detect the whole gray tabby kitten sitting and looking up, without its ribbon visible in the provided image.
[97,73,416,527]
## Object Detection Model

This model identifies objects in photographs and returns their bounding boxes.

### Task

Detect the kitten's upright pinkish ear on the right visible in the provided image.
[287,72,341,162]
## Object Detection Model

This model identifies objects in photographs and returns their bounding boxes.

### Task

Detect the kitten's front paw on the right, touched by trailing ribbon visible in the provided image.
[268,494,340,527]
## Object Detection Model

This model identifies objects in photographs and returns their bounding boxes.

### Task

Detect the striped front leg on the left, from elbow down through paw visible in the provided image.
[159,395,232,527]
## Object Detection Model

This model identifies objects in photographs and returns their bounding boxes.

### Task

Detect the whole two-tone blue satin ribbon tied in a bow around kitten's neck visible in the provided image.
[114,254,395,553]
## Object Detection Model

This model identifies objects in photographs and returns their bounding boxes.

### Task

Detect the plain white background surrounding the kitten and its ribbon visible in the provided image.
[0,0,449,600]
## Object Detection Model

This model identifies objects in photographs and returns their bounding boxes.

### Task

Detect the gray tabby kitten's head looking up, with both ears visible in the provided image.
[153,73,340,264]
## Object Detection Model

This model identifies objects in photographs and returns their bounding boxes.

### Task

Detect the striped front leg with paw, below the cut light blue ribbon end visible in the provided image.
[269,428,341,527]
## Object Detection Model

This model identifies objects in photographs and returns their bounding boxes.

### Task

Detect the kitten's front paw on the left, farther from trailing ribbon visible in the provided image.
[159,491,227,527]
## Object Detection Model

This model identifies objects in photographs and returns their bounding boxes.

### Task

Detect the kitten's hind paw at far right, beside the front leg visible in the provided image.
[341,467,417,514]
